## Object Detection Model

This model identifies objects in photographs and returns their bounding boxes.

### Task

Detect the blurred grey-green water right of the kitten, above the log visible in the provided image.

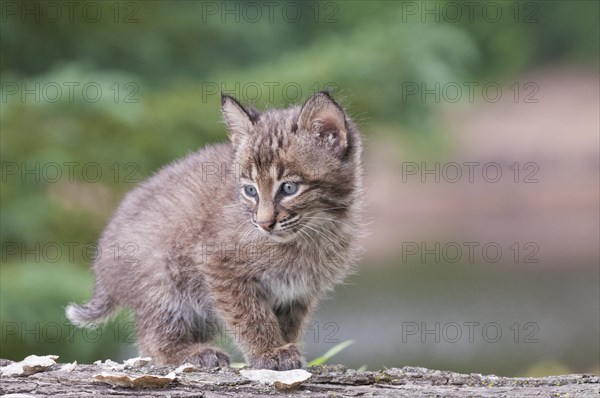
[305,263,600,376]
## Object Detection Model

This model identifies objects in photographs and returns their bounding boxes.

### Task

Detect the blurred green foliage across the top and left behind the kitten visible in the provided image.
[0,1,599,370]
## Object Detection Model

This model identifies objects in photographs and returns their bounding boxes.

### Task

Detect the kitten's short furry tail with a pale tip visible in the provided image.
[65,284,117,327]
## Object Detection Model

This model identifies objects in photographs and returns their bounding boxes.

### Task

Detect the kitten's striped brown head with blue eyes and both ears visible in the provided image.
[221,92,361,242]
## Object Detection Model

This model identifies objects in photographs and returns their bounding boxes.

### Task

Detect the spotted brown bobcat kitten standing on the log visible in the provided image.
[66,92,362,370]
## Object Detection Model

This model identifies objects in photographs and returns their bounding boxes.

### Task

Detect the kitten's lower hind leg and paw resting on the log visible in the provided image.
[138,310,229,368]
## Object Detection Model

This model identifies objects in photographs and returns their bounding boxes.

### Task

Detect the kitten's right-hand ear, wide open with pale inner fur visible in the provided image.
[298,91,348,156]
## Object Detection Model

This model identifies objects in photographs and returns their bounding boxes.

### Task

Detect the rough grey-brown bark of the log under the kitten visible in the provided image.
[0,360,600,398]
